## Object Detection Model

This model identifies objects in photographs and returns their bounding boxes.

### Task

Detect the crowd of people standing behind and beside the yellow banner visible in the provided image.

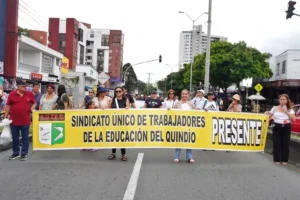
[0,81,295,165]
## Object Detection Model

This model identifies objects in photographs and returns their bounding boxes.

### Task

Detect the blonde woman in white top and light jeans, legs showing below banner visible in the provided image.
[174,90,196,163]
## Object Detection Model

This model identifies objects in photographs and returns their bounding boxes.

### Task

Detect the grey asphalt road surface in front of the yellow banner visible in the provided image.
[0,146,300,200]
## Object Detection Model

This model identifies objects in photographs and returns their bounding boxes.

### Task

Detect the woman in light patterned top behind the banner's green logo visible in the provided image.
[39,84,58,110]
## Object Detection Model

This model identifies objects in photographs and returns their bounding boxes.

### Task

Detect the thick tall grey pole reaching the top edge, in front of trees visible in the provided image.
[204,0,212,93]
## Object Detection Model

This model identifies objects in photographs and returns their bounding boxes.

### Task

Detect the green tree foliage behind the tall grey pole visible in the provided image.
[158,41,273,93]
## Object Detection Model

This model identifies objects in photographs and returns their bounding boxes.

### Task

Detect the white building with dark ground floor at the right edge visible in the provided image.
[253,49,300,103]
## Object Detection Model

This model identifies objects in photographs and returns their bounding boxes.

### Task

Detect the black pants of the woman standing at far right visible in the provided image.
[273,124,291,162]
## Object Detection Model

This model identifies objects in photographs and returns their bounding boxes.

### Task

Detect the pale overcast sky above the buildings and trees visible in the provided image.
[19,0,300,82]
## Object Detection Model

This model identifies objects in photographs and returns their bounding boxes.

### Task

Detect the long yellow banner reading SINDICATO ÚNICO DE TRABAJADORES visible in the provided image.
[33,109,268,151]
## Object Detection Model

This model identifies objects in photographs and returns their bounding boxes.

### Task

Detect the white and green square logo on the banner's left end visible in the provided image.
[39,123,65,146]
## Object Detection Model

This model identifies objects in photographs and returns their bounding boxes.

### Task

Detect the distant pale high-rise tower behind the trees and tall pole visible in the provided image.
[179,25,227,63]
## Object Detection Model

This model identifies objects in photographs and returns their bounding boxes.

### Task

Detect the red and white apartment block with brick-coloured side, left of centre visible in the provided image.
[49,18,124,85]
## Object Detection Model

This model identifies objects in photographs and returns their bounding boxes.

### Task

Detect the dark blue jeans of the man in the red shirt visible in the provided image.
[10,125,30,155]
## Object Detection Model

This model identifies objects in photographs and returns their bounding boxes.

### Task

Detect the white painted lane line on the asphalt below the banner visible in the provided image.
[123,153,144,200]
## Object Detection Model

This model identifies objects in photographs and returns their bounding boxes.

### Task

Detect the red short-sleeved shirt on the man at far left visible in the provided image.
[6,90,35,126]
